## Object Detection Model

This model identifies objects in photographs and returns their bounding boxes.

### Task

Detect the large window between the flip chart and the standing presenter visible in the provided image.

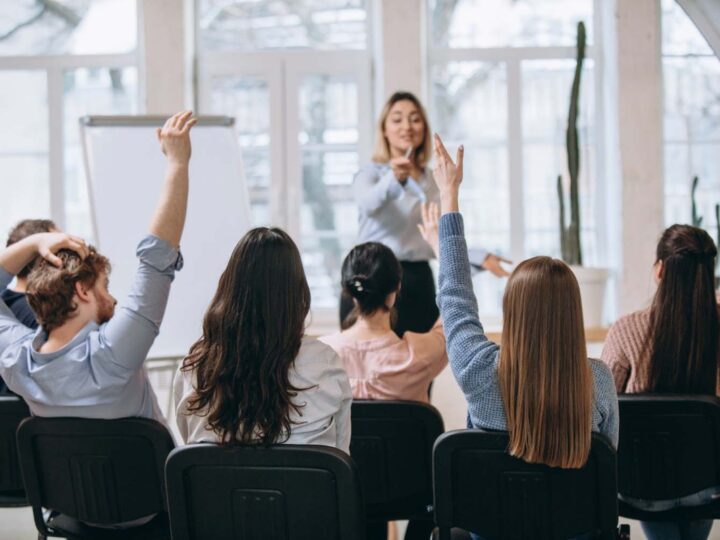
[196,0,372,324]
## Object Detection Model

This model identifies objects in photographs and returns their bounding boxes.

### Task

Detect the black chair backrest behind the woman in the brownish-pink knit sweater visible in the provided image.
[618,394,720,500]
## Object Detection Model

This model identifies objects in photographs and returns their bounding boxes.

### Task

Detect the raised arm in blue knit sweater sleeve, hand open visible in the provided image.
[435,135,498,396]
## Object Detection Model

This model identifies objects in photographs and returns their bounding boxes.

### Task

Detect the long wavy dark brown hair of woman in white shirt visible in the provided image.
[183,227,310,444]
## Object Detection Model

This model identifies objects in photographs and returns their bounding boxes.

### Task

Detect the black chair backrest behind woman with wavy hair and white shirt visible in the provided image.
[165,444,365,540]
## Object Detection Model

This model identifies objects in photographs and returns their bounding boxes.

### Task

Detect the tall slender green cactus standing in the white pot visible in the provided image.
[557,21,585,265]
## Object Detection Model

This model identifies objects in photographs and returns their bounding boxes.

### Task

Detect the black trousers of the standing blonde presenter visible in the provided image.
[340,261,440,337]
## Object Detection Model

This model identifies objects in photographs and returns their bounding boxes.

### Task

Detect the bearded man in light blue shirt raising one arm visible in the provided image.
[0,111,195,421]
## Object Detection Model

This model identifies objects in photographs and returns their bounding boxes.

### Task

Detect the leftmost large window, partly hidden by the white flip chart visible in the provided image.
[0,0,138,237]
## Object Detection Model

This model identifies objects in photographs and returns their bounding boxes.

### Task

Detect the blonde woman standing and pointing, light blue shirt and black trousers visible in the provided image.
[340,92,507,337]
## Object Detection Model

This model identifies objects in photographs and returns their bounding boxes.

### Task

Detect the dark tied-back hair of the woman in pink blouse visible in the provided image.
[341,242,402,330]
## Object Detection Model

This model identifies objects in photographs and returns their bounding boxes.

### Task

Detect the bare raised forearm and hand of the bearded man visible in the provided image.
[150,111,197,247]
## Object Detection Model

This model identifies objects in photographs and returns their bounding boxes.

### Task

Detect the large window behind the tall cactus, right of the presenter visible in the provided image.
[428,0,604,315]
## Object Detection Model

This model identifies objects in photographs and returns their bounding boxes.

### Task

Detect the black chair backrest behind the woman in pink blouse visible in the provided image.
[350,400,444,521]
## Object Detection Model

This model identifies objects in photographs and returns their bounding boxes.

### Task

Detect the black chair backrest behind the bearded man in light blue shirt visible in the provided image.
[17,417,174,540]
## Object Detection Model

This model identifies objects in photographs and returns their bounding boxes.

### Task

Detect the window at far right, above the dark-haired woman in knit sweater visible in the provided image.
[662,0,720,238]
